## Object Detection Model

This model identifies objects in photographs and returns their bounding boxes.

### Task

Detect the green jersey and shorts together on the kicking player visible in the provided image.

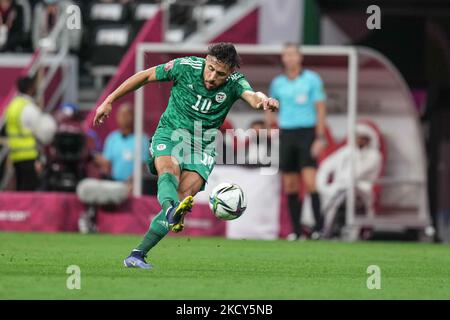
[148,57,253,181]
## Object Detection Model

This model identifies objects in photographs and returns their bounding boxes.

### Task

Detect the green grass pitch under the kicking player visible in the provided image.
[0,232,450,299]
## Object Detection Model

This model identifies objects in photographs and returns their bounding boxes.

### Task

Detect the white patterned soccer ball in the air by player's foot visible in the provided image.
[209,182,247,220]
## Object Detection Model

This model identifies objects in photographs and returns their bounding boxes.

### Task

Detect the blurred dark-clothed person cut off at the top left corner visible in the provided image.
[0,0,24,52]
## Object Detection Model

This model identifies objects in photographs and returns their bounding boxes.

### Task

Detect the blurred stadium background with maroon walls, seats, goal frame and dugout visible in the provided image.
[0,0,450,258]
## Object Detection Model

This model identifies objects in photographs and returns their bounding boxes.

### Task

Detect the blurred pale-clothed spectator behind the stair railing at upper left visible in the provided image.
[32,0,82,51]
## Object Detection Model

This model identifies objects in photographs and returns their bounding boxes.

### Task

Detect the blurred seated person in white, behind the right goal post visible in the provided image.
[317,123,382,237]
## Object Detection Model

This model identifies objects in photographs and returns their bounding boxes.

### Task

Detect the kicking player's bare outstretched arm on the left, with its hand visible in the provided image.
[94,67,157,126]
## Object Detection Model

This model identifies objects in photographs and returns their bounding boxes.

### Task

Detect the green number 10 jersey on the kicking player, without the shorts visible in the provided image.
[156,57,253,134]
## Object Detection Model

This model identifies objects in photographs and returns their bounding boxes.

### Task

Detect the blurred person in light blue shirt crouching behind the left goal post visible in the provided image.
[77,103,149,233]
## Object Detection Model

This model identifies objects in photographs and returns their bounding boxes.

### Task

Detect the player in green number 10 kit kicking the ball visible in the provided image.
[94,43,278,269]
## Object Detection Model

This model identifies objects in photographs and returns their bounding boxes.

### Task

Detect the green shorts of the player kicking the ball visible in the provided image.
[148,128,216,190]
